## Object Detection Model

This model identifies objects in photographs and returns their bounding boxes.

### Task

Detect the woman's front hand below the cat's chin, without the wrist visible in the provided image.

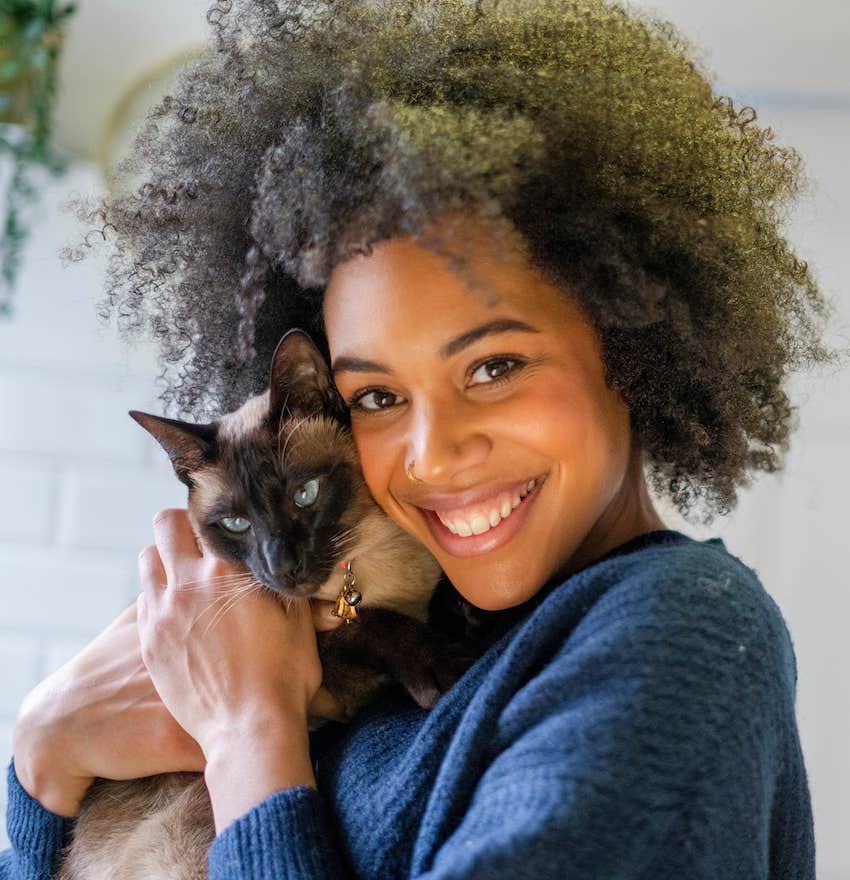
[138,509,342,756]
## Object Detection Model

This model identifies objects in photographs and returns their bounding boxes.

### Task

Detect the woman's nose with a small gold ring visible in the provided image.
[404,403,492,485]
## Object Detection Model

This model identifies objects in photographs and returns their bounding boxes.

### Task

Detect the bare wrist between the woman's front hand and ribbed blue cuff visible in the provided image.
[204,712,316,834]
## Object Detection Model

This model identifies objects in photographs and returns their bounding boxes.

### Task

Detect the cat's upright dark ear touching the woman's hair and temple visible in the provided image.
[269,330,346,418]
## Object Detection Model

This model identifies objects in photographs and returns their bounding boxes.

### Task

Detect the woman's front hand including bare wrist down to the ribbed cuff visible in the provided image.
[138,510,341,829]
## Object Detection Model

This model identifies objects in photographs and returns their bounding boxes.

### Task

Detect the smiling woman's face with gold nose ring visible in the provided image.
[325,229,664,609]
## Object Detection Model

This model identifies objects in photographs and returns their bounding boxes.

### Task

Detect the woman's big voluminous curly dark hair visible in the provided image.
[68,0,837,522]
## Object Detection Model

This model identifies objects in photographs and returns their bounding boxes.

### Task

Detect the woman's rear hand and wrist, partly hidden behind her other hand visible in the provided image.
[13,603,205,816]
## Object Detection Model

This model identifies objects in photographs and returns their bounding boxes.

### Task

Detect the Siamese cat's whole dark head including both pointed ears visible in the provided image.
[133,333,375,597]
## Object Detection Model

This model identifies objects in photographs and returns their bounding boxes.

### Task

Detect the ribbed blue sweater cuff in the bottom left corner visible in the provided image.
[0,760,74,880]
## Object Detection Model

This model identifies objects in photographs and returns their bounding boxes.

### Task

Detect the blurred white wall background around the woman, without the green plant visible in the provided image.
[0,0,850,880]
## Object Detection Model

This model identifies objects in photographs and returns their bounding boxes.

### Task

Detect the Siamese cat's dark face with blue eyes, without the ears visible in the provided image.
[197,406,371,596]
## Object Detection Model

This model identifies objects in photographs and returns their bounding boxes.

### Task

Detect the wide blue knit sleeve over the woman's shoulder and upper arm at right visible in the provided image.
[411,560,814,880]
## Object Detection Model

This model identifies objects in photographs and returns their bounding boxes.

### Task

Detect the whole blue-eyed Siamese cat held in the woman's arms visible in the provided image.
[57,330,474,880]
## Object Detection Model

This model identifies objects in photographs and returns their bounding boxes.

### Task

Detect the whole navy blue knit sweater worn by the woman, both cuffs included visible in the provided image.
[0,530,814,880]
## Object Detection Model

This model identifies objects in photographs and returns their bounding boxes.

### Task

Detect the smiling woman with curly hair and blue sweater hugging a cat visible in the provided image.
[0,0,834,880]
